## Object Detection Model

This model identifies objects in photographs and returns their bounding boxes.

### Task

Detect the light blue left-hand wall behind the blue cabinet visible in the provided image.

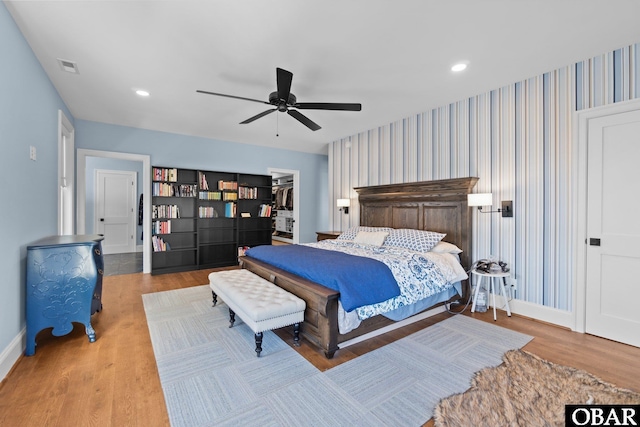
[0,3,73,356]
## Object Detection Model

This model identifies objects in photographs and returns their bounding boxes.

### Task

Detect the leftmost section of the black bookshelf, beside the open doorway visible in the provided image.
[151,167,198,274]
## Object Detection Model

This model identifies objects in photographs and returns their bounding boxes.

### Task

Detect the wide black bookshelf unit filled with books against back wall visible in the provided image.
[151,167,271,274]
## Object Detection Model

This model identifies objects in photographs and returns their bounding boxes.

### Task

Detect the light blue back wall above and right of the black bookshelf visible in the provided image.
[75,120,329,243]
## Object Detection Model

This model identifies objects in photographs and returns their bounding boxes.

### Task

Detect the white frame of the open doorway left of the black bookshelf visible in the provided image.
[76,148,151,273]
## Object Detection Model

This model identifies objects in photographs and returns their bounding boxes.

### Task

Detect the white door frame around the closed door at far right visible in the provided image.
[572,99,640,333]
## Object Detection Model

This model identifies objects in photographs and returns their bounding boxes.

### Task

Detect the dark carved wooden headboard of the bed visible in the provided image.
[355,177,478,270]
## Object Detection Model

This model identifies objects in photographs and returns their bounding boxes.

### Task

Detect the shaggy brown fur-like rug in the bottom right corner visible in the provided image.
[434,350,640,427]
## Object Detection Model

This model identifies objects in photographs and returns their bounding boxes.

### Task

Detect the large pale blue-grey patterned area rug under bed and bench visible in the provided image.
[143,285,532,427]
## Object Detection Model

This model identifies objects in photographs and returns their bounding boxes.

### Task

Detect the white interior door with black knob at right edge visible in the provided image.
[585,110,640,347]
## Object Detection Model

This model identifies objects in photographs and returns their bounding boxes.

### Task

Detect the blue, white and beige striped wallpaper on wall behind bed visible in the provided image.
[329,44,640,311]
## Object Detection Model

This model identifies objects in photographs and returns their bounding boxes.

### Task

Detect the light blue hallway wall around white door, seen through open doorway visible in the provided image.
[85,156,142,245]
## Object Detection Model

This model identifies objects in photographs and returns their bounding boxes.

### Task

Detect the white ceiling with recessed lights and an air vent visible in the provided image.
[4,0,640,153]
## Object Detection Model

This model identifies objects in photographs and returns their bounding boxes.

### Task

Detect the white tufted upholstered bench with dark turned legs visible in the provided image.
[209,269,306,357]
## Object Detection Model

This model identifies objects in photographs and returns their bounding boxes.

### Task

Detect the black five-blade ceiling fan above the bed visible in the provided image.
[196,68,362,131]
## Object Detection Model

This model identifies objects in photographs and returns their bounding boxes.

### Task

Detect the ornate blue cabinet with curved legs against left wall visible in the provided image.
[25,235,104,356]
